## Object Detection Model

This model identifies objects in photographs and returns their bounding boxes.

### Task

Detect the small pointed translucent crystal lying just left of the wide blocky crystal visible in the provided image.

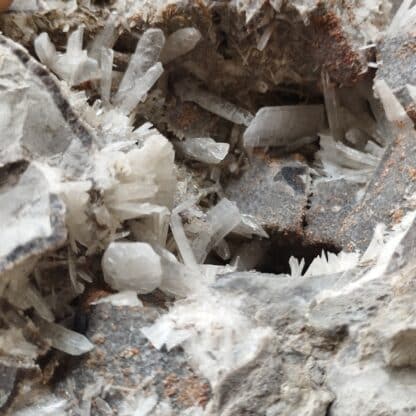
[176,137,230,165]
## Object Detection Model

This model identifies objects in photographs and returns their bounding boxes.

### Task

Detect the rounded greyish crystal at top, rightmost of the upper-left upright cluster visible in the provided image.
[160,27,202,64]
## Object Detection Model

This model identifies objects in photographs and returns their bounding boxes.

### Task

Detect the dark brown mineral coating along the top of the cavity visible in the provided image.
[0,1,366,100]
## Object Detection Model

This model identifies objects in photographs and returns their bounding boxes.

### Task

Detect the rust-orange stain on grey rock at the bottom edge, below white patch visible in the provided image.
[163,374,211,407]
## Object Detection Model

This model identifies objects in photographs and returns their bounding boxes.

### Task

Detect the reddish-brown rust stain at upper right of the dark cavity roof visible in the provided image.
[311,7,365,84]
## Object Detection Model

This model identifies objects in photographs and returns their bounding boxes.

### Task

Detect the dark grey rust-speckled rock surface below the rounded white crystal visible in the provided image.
[55,303,211,416]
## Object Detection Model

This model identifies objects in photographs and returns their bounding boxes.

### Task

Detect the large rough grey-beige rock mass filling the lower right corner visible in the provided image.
[214,254,416,416]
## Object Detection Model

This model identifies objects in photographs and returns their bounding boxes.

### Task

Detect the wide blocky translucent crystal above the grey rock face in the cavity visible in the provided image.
[243,105,325,147]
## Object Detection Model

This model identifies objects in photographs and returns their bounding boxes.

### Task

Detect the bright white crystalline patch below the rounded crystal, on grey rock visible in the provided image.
[141,292,271,387]
